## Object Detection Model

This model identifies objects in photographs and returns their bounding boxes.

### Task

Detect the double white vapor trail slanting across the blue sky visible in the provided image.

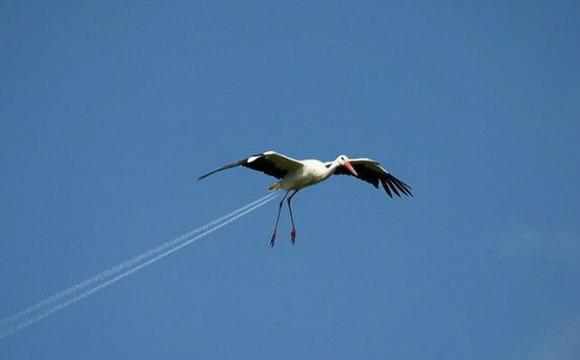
[0,193,278,339]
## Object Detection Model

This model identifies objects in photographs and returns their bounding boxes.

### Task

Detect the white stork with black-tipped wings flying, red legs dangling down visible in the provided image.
[199,151,413,247]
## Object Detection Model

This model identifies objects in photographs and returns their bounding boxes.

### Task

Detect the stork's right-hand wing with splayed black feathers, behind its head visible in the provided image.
[325,158,413,197]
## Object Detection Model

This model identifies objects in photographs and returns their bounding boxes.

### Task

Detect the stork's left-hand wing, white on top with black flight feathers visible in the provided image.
[198,151,302,180]
